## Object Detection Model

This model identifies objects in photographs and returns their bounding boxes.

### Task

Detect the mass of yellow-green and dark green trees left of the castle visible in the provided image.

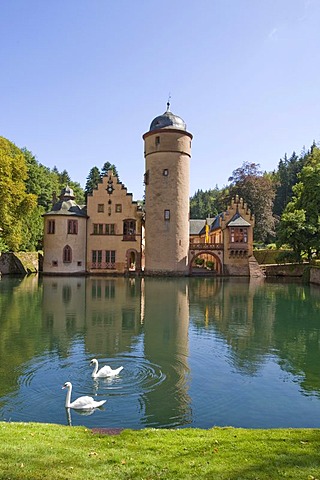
[0,137,85,252]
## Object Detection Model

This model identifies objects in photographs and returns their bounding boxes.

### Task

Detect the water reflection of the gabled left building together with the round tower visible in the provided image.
[43,277,190,425]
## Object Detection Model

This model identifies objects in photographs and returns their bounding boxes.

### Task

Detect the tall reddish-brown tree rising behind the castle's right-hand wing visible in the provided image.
[229,162,275,242]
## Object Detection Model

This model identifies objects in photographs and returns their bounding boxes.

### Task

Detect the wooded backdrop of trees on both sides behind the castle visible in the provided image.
[0,137,320,261]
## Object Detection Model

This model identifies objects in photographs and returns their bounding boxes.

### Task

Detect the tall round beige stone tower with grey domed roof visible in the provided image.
[143,103,192,275]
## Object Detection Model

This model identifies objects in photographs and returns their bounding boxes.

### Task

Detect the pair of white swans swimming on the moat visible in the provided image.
[62,358,123,410]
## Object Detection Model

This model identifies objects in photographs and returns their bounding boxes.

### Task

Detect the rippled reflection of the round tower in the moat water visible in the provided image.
[144,278,191,426]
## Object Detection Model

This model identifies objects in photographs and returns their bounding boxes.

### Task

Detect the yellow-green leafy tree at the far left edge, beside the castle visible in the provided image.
[0,137,37,251]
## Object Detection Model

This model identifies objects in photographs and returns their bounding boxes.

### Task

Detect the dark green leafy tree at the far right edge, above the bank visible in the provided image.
[278,147,320,260]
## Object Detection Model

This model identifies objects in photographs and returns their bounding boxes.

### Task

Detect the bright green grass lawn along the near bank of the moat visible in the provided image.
[0,422,320,480]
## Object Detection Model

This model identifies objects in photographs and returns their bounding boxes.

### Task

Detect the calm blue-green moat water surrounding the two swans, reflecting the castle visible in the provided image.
[0,276,320,429]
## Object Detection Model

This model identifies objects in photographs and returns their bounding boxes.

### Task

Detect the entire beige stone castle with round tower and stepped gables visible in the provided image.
[43,104,254,276]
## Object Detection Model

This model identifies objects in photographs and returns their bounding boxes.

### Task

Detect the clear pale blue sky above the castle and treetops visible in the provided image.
[0,0,320,200]
